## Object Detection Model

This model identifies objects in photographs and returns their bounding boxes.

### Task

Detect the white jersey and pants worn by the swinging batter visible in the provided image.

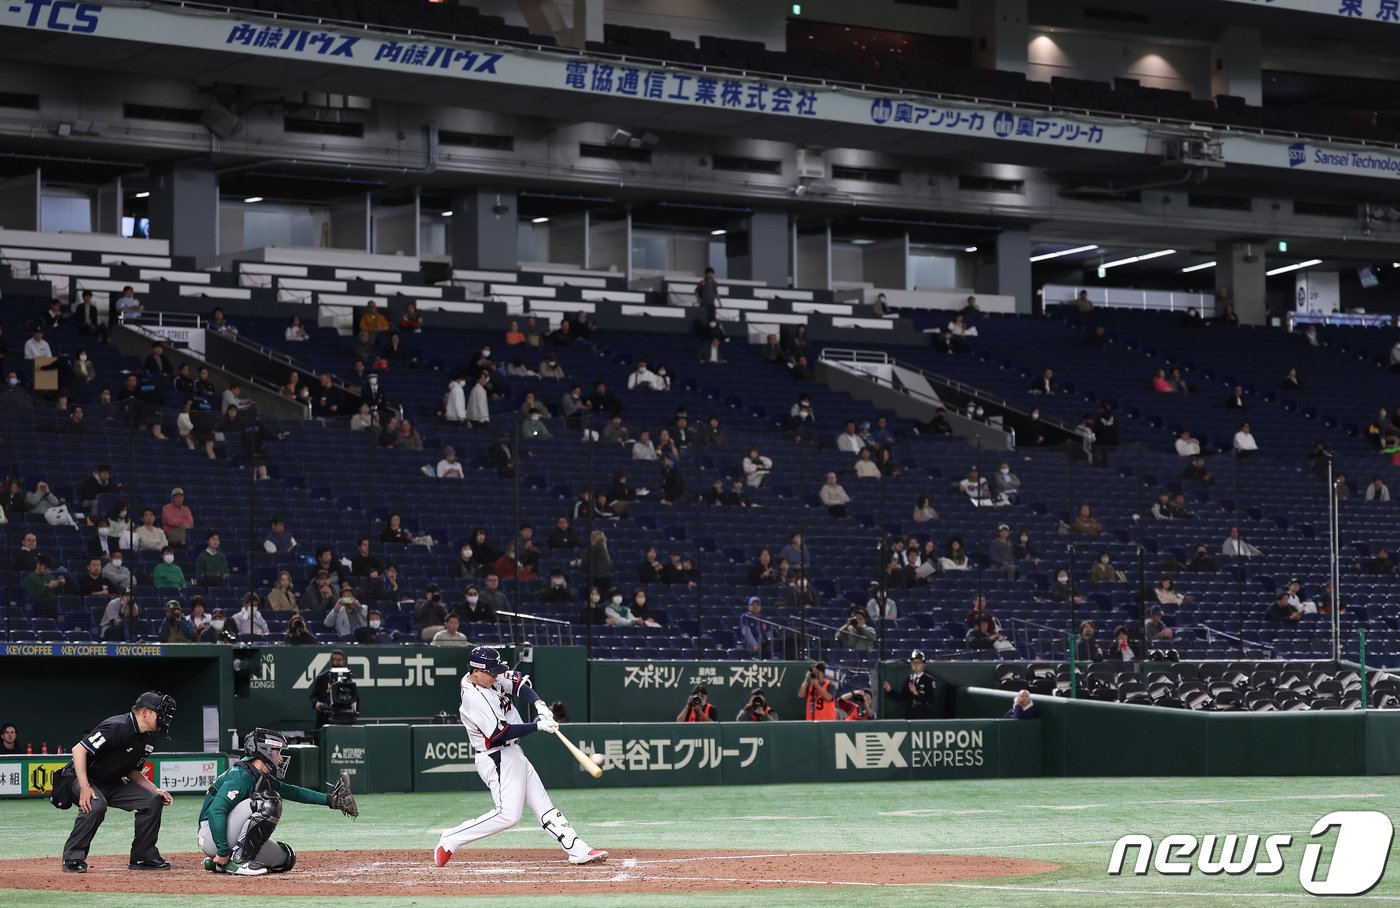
[438,672,592,862]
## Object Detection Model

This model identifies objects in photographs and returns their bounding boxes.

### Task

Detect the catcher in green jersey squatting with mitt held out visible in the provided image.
[199,729,360,876]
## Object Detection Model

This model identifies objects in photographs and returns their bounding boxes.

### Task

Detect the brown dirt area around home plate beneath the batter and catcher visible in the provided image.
[0,846,1058,897]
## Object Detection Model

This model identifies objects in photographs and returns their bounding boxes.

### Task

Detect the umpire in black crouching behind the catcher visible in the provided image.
[55,691,175,873]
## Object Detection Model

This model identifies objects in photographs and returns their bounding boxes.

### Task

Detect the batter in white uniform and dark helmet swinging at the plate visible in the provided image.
[433,646,608,867]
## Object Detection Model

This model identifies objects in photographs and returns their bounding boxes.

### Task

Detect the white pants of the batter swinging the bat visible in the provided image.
[438,746,591,858]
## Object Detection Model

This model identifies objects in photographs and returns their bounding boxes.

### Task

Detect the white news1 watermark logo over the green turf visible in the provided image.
[1109,810,1394,895]
